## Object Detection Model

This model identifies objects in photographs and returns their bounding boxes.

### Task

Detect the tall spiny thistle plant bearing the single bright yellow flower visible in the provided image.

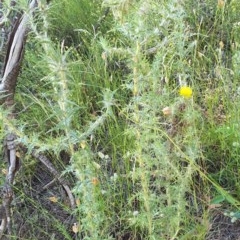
[100,1,203,239]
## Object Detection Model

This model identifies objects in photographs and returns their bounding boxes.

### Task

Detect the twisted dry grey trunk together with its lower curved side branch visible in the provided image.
[0,0,75,239]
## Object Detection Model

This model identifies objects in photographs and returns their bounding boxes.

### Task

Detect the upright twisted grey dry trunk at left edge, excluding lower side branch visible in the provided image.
[0,0,37,239]
